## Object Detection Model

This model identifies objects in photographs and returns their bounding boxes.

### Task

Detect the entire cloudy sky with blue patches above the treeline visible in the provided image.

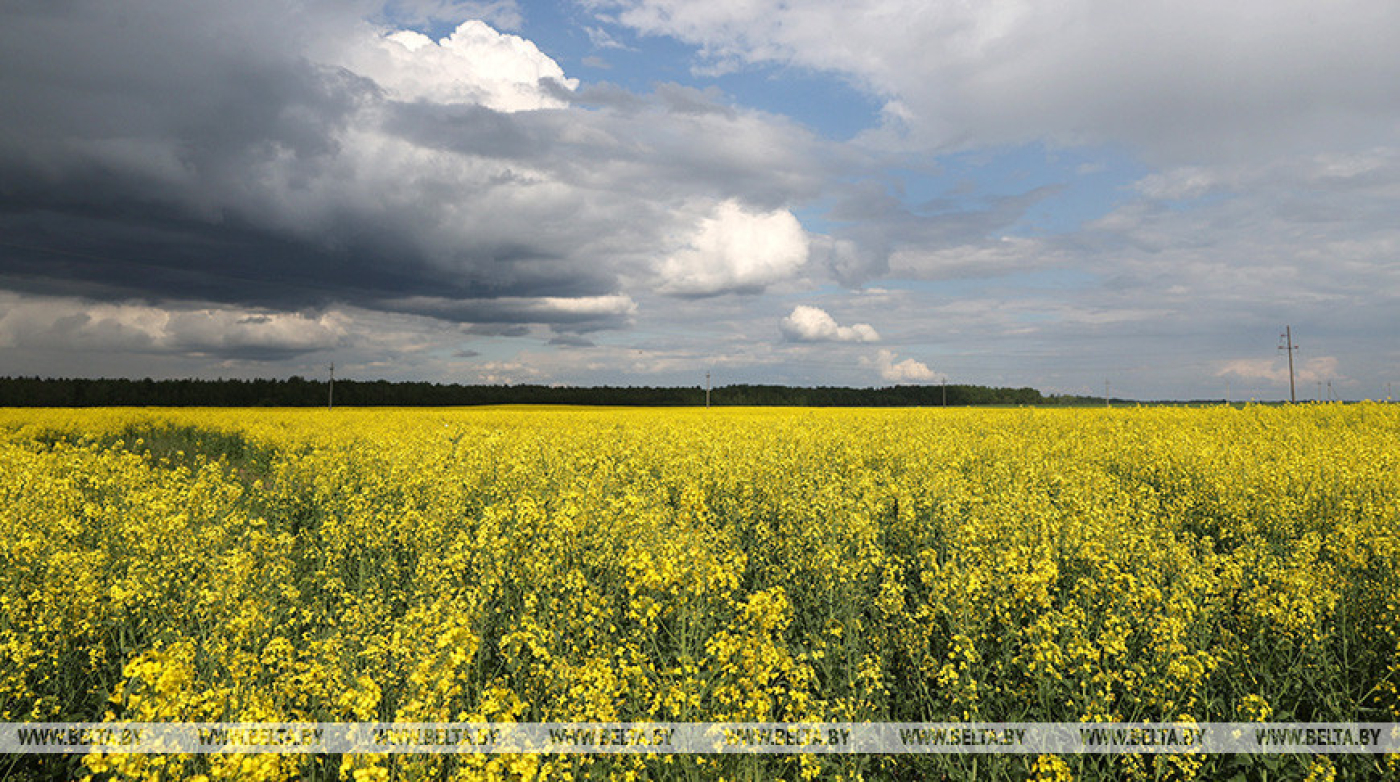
[0,0,1400,401]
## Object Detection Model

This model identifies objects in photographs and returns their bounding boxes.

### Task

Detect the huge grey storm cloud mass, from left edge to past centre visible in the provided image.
[0,0,845,332]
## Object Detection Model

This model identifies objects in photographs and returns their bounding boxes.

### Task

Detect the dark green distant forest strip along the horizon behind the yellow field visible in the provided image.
[0,376,1080,407]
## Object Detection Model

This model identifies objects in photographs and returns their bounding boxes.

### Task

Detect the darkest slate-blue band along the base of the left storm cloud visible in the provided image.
[0,208,609,311]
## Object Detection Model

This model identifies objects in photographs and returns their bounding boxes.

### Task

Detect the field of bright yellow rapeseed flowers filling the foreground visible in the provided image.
[0,404,1400,781]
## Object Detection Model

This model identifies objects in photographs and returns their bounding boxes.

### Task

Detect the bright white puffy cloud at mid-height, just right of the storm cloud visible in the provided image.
[659,200,808,297]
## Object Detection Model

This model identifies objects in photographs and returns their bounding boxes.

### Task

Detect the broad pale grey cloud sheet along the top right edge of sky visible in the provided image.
[594,0,1400,161]
